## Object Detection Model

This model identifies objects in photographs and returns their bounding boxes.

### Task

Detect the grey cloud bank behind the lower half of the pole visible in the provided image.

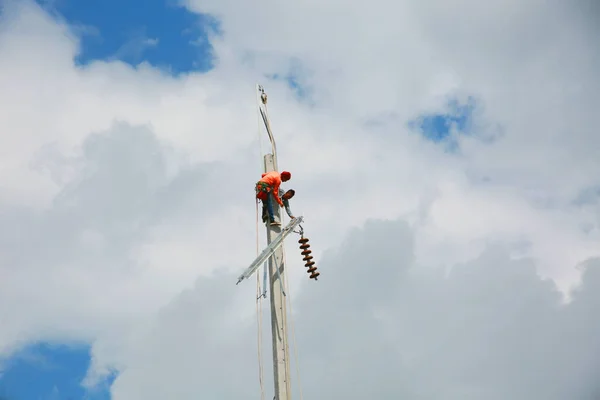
[105,220,600,400]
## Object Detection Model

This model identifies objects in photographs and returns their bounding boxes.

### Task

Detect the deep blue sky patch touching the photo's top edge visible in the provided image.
[38,0,219,74]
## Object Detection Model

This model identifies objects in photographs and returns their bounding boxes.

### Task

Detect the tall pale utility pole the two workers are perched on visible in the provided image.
[258,86,292,400]
